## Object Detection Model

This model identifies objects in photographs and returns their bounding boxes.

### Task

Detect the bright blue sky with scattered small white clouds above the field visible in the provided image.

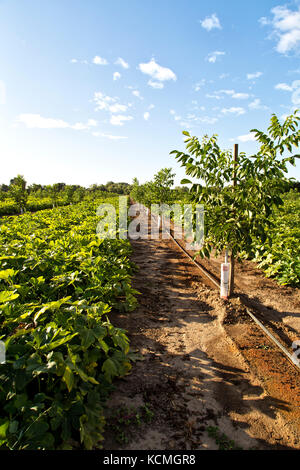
[0,0,300,186]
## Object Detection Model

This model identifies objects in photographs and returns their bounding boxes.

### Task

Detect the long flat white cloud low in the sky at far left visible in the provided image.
[17,113,97,131]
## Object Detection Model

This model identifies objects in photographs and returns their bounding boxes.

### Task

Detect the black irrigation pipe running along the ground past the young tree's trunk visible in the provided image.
[150,209,300,372]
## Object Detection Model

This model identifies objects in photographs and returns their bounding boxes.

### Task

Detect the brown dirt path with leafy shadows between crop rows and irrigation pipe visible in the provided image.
[104,214,300,450]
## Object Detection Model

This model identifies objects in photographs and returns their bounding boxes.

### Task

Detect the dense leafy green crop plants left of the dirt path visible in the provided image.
[0,198,136,449]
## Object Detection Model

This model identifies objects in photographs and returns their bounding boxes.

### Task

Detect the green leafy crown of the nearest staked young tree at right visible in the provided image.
[171,111,300,264]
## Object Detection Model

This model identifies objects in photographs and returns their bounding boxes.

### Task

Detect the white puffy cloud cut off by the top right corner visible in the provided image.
[259,5,300,54]
